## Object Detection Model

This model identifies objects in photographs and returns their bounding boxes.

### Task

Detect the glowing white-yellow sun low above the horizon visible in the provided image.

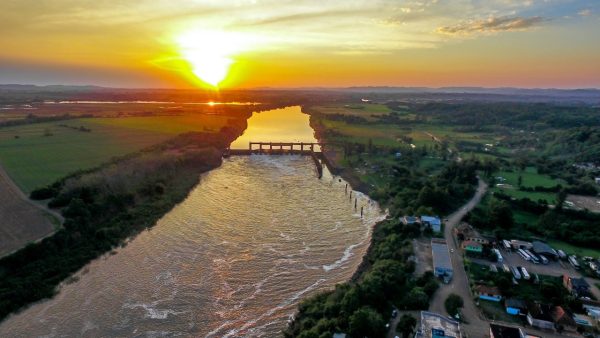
[177,29,253,87]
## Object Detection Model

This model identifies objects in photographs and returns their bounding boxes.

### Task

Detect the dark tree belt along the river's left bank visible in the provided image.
[0,125,245,320]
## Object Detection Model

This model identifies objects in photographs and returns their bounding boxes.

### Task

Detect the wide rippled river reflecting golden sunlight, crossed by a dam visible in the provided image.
[0,107,382,337]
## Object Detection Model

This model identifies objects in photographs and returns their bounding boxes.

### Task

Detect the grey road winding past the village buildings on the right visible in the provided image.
[429,179,489,337]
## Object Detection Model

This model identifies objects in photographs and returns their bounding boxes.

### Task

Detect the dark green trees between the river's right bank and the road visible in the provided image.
[284,159,481,338]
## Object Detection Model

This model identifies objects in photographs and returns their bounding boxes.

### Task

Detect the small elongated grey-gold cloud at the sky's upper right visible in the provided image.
[437,16,549,35]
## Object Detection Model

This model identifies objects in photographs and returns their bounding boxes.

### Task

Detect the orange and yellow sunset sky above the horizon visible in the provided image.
[0,0,600,88]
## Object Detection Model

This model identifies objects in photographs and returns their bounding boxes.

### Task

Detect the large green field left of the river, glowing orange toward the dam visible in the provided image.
[0,115,227,193]
